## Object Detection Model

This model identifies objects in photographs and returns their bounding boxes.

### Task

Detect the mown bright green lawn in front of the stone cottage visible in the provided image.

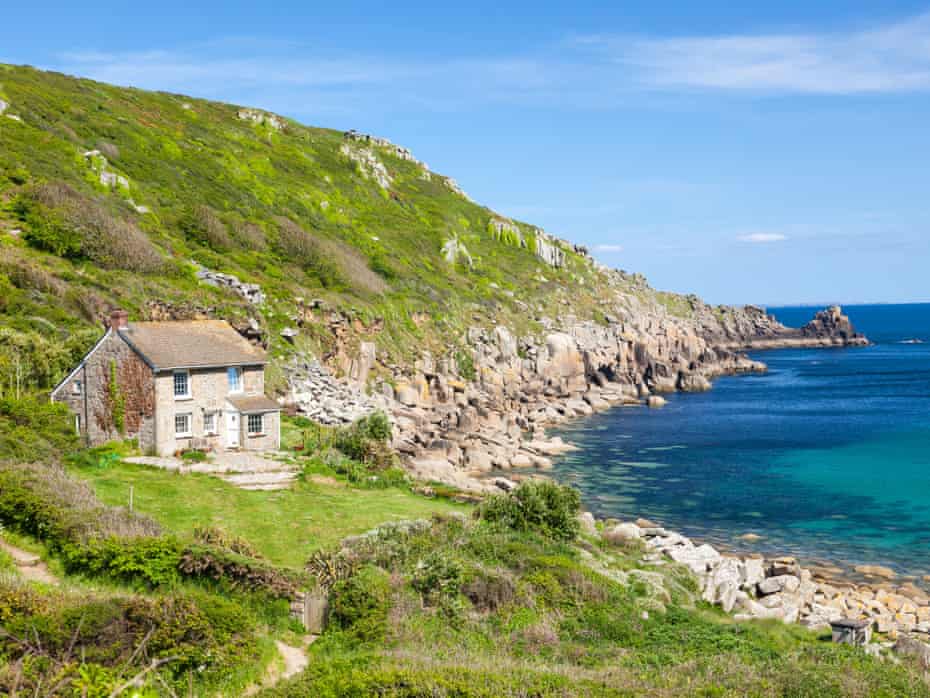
[72,463,467,568]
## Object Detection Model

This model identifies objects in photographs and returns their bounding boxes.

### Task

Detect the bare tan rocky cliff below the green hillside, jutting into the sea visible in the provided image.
[280,262,867,491]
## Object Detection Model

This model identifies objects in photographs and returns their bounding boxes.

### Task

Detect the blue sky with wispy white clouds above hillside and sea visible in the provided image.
[0,0,930,304]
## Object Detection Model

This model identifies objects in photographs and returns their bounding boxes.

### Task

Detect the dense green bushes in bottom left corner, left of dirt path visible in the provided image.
[0,577,258,697]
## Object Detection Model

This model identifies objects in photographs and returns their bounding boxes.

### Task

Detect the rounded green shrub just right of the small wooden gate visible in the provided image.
[330,565,391,642]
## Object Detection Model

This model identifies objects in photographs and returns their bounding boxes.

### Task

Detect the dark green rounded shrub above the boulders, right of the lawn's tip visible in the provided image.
[477,480,581,540]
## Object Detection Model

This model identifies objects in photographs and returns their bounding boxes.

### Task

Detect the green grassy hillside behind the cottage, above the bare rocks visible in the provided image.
[0,66,646,396]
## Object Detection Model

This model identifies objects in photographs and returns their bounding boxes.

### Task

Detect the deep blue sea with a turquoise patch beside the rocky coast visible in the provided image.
[553,304,930,575]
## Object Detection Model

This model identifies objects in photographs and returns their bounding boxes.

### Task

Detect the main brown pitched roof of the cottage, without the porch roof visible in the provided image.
[119,320,268,371]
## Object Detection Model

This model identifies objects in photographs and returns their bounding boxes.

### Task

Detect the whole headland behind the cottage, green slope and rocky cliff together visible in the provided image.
[0,66,864,484]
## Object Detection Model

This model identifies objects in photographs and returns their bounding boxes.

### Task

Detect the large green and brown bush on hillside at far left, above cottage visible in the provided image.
[16,182,165,272]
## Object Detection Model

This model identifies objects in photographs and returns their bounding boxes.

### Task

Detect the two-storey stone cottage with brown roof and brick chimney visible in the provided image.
[51,310,281,455]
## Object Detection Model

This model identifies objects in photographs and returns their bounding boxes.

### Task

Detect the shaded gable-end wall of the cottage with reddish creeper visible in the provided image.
[52,333,155,451]
